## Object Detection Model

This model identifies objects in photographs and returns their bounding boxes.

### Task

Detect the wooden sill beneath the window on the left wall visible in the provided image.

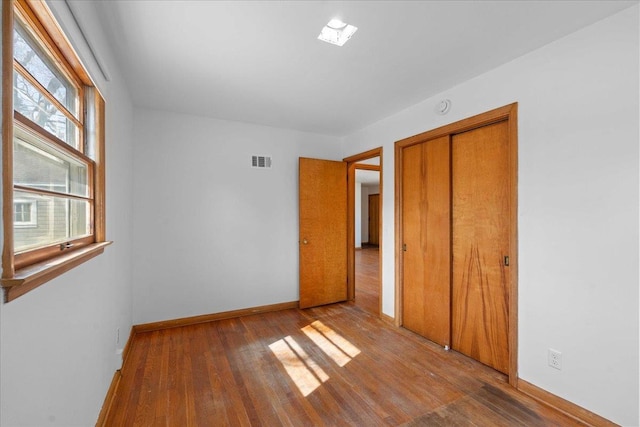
[0,242,113,303]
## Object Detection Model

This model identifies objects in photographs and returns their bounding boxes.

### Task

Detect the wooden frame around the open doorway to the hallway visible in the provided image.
[342,147,383,316]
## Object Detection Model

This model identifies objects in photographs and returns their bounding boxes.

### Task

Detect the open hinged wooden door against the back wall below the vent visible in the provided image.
[299,158,347,308]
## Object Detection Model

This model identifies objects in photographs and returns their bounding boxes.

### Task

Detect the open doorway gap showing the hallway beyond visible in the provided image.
[354,162,380,316]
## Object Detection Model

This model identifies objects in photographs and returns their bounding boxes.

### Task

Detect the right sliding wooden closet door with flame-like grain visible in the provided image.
[452,121,511,373]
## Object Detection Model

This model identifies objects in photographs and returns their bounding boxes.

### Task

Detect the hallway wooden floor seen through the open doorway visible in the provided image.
[355,246,380,316]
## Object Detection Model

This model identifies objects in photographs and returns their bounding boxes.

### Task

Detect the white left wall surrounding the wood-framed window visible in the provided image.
[0,2,133,427]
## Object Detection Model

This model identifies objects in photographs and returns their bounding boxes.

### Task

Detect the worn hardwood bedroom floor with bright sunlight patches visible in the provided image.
[106,303,580,427]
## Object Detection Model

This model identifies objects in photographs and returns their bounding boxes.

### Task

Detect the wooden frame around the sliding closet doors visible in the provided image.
[394,102,518,387]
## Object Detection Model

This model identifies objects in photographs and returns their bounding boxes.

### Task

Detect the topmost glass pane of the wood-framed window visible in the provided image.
[13,22,78,118]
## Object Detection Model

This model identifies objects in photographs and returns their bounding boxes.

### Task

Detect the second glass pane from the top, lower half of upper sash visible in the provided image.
[13,72,79,149]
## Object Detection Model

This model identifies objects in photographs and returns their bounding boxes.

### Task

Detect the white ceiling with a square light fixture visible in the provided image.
[97,0,637,135]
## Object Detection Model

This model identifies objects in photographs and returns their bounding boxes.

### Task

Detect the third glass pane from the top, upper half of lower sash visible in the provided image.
[13,126,89,197]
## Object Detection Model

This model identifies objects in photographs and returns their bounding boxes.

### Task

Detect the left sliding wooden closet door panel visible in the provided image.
[402,136,451,346]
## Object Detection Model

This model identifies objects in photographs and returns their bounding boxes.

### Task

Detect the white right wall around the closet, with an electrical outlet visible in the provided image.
[344,6,639,425]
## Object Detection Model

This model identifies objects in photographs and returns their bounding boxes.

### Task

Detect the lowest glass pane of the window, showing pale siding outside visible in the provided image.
[13,191,91,252]
